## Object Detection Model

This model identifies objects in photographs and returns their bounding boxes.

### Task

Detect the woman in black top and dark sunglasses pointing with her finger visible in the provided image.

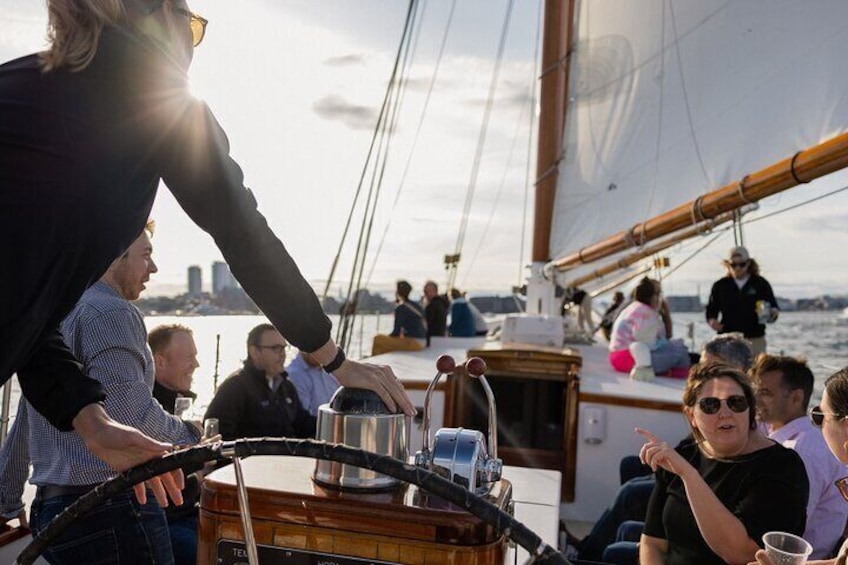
[637,365,809,565]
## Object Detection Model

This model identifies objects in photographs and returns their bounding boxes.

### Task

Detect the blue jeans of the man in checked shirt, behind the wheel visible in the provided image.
[30,491,174,565]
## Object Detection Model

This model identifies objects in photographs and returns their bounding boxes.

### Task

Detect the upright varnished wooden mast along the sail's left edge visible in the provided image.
[532,0,574,263]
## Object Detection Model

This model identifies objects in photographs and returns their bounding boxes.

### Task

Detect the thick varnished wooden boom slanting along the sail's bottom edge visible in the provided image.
[552,133,848,269]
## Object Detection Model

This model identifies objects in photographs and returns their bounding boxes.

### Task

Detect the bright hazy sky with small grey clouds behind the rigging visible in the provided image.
[0,0,848,298]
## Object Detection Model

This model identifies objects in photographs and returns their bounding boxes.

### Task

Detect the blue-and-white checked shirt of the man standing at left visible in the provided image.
[0,282,199,516]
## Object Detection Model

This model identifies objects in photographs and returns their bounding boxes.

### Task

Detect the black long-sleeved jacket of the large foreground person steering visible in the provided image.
[0,29,331,430]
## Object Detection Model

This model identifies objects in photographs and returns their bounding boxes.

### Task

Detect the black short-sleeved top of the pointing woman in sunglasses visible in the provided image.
[644,443,810,565]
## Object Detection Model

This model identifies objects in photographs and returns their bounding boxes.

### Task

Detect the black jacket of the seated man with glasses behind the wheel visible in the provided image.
[204,363,315,440]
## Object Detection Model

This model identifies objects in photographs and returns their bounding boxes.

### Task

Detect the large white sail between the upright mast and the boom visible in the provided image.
[550,0,848,264]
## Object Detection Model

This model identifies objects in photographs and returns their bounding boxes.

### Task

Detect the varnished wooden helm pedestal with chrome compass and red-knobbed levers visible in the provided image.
[198,356,522,565]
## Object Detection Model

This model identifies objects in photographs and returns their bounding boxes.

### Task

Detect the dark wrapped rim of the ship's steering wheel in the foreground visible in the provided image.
[17,438,569,565]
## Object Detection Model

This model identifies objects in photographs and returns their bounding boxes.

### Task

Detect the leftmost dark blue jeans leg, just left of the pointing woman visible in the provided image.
[580,475,656,561]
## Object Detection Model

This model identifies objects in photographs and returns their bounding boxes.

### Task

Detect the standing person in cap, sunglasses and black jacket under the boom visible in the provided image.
[706,247,780,357]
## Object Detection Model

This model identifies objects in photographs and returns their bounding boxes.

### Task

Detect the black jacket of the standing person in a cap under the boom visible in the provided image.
[707,275,777,337]
